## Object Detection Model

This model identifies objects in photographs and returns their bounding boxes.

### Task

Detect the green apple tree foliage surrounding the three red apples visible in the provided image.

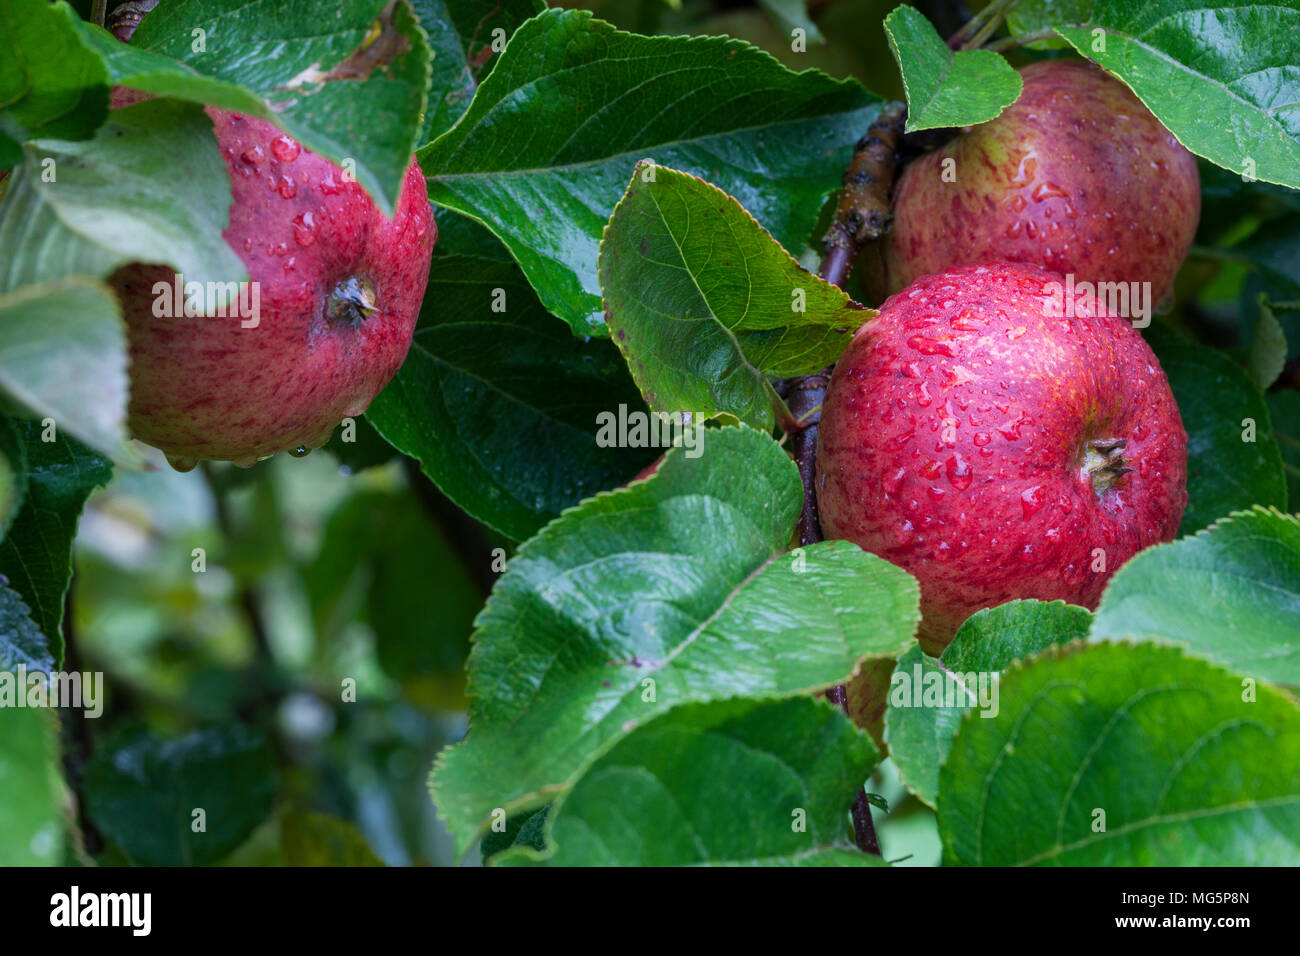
[0,0,1300,865]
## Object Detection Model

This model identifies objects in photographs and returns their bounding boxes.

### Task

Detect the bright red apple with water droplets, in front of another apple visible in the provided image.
[816,263,1187,649]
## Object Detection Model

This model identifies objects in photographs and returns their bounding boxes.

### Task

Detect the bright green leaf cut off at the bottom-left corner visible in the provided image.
[0,708,64,866]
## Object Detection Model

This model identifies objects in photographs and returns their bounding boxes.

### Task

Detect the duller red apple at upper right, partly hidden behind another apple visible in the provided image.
[863,60,1201,306]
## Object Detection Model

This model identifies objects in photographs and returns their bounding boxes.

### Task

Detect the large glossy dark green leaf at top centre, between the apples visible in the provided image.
[420,9,880,334]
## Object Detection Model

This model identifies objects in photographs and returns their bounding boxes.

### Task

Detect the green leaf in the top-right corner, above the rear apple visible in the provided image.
[1057,0,1300,187]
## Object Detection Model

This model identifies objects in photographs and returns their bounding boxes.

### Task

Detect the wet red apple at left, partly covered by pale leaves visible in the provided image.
[113,94,438,464]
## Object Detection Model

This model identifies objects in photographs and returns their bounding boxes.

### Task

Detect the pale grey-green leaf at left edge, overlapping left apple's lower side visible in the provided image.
[0,277,134,460]
